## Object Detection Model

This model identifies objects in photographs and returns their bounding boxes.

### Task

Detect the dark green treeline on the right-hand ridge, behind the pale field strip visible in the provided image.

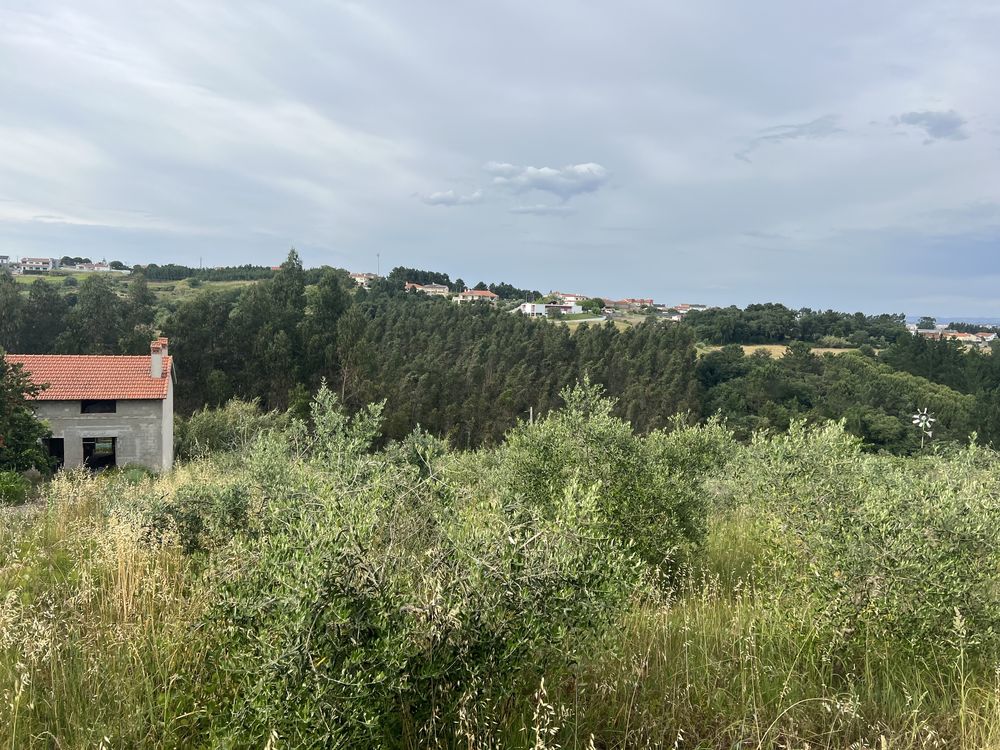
[684,303,908,348]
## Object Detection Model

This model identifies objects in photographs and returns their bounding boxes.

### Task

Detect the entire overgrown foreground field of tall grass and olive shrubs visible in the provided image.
[0,386,1000,750]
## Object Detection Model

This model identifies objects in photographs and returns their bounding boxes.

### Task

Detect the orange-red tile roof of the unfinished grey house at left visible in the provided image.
[5,354,173,401]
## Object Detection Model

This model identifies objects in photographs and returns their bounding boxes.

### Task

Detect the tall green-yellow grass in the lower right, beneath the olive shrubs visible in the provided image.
[550,519,1000,748]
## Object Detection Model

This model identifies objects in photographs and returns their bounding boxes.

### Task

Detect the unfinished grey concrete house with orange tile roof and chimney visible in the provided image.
[5,339,175,471]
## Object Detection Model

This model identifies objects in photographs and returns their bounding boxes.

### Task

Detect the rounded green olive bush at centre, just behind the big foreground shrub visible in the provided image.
[494,382,733,576]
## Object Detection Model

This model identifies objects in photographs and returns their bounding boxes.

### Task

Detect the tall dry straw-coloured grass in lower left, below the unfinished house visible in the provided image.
[0,474,203,749]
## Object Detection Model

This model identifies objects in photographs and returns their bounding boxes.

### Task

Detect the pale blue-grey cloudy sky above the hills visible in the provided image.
[0,0,1000,316]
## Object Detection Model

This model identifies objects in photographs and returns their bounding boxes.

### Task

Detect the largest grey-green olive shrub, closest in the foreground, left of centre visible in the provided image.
[194,389,644,747]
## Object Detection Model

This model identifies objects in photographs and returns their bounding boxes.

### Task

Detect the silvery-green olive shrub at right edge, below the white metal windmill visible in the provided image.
[736,423,1000,658]
